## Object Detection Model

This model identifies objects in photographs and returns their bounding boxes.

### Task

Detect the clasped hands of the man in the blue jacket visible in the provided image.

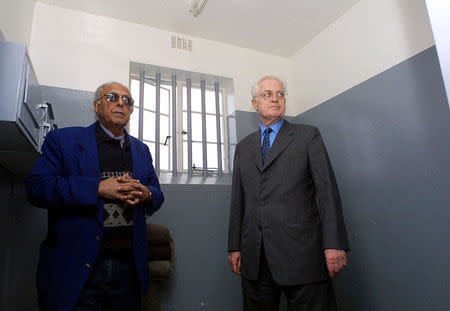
[98,174,152,205]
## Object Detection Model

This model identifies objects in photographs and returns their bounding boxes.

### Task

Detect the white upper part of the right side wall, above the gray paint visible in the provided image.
[289,0,434,115]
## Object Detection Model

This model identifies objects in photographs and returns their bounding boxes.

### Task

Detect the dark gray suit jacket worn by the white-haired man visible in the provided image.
[228,120,349,285]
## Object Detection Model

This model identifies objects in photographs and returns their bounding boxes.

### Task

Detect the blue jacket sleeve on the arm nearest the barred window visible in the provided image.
[142,145,164,216]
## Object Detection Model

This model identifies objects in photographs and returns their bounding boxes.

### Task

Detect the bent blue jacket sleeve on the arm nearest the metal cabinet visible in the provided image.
[25,131,100,209]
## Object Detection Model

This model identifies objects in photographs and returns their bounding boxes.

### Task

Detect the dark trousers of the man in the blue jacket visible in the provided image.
[73,255,141,311]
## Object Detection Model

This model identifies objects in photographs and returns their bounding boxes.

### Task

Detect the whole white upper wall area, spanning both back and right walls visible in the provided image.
[30,0,434,115]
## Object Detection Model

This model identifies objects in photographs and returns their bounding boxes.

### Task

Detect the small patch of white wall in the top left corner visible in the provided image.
[0,0,36,46]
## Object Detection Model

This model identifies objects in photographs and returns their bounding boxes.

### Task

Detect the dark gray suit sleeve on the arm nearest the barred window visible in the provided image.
[228,145,245,252]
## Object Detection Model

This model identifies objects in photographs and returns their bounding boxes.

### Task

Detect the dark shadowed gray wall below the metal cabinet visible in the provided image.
[0,171,47,311]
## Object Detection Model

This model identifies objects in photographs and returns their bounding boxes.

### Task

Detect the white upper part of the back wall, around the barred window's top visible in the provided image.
[30,2,291,111]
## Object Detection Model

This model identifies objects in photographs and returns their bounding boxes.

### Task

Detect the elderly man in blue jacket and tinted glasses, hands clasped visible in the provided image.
[25,82,164,311]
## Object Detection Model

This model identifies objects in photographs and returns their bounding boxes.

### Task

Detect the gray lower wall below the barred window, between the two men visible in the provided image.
[151,185,242,311]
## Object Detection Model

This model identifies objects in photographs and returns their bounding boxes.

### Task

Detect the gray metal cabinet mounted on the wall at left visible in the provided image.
[0,40,52,175]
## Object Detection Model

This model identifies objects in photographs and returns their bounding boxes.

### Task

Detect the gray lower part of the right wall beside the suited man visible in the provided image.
[297,47,450,311]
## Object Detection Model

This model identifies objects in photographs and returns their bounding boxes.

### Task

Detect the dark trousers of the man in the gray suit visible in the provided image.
[242,246,336,311]
